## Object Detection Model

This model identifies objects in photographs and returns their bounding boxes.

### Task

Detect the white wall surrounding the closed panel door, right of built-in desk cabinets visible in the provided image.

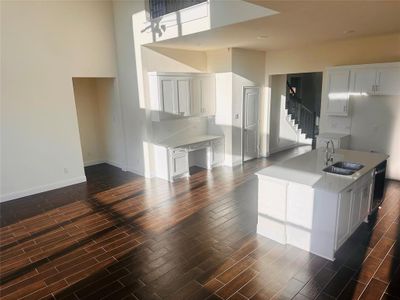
[207,48,266,166]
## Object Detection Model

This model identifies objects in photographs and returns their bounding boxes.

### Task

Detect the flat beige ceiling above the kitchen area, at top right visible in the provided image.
[149,0,400,50]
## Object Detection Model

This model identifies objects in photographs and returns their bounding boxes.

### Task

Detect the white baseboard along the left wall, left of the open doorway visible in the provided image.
[0,176,86,202]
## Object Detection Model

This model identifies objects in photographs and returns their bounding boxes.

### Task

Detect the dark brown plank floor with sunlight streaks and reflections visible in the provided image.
[0,147,400,300]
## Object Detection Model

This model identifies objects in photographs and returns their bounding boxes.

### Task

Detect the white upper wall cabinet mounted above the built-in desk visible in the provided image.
[149,72,215,121]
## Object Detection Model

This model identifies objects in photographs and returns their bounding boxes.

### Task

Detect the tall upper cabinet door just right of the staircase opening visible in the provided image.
[327,69,350,116]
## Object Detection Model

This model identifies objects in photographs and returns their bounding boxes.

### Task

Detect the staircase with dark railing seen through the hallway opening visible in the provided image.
[285,81,318,149]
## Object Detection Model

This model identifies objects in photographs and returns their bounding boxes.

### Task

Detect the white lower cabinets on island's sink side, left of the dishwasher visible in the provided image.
[335,172,373,249]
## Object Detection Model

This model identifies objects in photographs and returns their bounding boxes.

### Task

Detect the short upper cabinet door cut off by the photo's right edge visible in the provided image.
[375,67,400,95]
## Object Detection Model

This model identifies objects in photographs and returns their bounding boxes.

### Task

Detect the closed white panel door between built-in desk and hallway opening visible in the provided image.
[242,88,260,161]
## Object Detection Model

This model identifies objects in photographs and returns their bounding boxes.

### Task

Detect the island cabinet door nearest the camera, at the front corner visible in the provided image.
[336,188,353,249]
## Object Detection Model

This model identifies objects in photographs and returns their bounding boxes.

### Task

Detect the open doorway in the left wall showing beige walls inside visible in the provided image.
[72,77,125,168]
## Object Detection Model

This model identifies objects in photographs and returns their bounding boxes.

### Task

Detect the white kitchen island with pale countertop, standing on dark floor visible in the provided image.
[256,149,388,260]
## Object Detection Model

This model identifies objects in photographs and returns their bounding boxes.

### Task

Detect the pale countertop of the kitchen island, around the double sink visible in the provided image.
[256,148,389,192]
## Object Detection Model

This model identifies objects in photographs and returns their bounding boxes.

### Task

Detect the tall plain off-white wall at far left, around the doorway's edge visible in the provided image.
[1,1,116,200]
